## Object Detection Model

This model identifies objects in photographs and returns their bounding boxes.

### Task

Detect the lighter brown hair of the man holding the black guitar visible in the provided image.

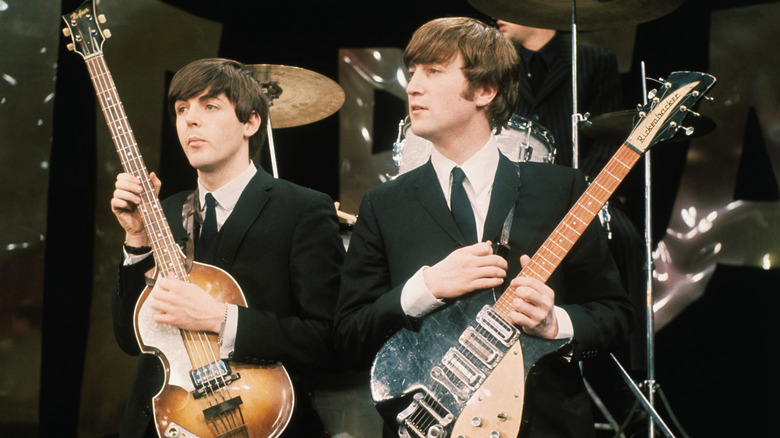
[404,17,520,128]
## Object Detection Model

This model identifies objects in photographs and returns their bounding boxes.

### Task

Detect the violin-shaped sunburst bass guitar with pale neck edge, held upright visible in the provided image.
[62,0,295,438]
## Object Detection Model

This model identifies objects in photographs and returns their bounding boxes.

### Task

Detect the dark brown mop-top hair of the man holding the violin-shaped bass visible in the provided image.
[168,58,269,159]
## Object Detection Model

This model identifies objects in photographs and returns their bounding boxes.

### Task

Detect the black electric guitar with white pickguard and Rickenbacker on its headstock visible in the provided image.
[371,72,715,438]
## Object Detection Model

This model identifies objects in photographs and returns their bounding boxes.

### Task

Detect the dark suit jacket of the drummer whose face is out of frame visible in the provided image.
[515,35,628,177]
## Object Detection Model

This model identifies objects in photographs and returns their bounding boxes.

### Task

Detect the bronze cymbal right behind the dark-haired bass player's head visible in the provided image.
[249,64,344,128]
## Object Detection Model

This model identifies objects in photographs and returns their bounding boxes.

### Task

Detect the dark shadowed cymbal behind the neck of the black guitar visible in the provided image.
[582,110,717,143]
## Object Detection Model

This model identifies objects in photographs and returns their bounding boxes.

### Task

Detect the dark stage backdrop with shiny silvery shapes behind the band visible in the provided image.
[0,0,780,438]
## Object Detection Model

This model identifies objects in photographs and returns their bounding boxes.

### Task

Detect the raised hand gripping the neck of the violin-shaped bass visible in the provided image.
[111,172,162,247]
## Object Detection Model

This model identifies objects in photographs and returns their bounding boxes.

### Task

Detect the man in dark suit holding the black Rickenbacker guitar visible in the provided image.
[335,17,632,438]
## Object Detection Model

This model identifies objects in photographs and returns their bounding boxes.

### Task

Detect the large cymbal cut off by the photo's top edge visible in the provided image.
[468,0,683,31]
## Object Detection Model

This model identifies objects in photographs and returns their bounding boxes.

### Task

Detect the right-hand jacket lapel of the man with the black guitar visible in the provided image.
[482,154,520,243]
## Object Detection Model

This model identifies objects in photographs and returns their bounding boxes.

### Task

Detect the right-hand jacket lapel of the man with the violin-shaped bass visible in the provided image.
[215,168,272,269]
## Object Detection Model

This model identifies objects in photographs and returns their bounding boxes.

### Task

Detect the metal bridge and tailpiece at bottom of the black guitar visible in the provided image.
[396,388,455,438]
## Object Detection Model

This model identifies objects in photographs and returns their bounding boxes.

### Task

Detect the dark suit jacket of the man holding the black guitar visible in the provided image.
[336,156,632,437]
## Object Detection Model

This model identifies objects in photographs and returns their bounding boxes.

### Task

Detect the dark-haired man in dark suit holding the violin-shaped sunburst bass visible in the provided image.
[111,59,344,437]
